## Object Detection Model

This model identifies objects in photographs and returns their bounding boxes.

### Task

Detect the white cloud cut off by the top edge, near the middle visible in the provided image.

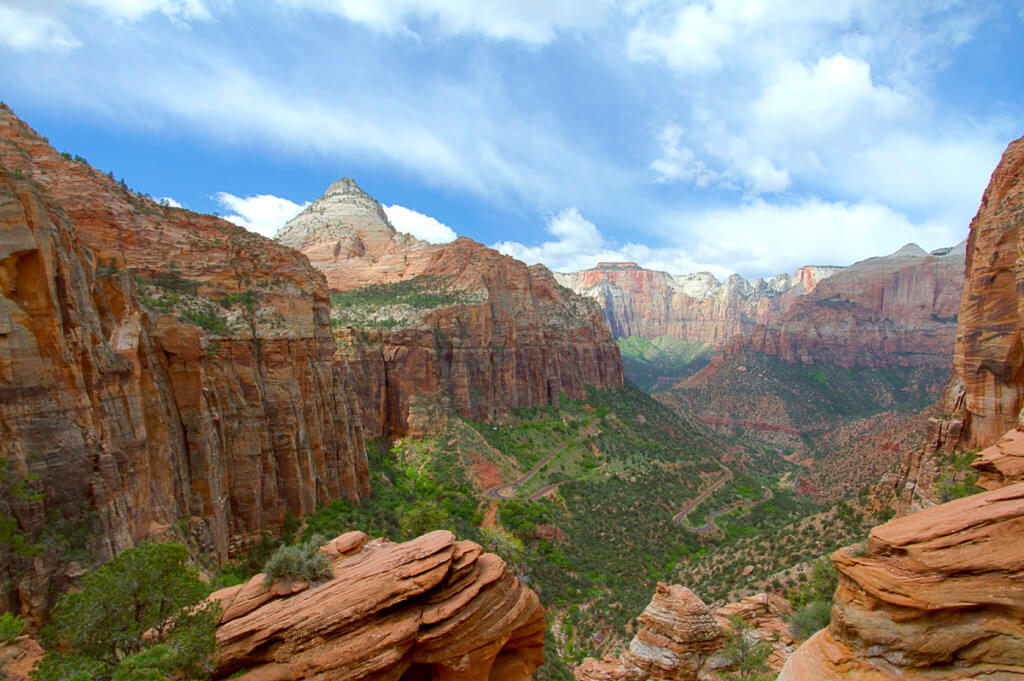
[278,0,607,45]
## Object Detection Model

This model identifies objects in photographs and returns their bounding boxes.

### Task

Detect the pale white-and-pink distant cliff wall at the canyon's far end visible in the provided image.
[555,262,841,345]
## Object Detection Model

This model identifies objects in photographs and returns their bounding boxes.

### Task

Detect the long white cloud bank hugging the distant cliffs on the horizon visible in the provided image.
[492,199,967,279]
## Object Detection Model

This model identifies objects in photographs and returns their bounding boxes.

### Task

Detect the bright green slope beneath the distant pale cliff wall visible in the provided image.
[615,336,714,392]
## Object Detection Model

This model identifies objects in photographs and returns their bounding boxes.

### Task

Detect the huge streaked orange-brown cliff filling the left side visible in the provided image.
[0,108,369,618]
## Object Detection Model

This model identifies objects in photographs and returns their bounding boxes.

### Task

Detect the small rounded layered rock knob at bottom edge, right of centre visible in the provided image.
[573,583,723,681]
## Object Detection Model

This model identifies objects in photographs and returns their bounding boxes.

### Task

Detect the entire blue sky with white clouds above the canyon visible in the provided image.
[0,0,1024,279]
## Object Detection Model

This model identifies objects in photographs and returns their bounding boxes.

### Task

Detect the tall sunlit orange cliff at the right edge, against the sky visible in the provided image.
[953,138,1024,448]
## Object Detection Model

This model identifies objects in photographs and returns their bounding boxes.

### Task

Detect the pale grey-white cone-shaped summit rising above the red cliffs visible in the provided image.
[276,177,397,251]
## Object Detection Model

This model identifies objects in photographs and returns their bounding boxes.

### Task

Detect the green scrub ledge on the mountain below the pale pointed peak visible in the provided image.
[331,274,473,329]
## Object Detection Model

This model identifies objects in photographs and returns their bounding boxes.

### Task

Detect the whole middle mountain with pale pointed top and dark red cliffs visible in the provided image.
[278,178,625,435]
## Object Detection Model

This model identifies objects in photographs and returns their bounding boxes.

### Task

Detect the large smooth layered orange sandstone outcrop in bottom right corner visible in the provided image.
[779,483,1024,681]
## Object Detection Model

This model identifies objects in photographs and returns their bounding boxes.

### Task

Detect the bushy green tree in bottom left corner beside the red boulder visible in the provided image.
[32,543,220,681]
